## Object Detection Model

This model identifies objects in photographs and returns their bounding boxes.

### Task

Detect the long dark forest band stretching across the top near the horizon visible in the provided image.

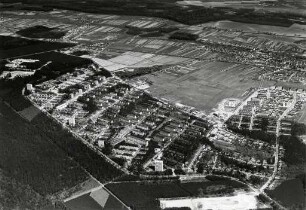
[3,0,301,27]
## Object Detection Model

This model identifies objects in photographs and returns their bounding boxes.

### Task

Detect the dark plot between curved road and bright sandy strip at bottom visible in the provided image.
[106,180,249,210]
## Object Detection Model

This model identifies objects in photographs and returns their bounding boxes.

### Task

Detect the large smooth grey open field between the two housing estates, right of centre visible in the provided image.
[142,62,274,111]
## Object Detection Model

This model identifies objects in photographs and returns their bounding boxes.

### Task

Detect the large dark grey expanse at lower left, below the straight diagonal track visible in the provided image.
[0,101,88,195]
